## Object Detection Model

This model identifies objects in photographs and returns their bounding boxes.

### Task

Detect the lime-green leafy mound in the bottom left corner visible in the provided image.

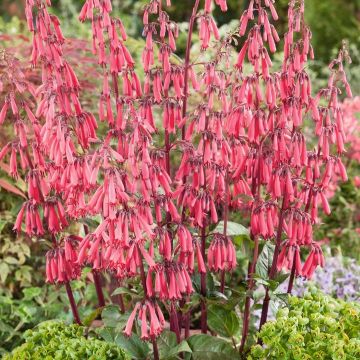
[4,321,127,360]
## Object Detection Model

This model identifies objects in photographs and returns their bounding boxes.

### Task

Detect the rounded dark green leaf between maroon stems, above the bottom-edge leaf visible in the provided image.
[208,305,240,337]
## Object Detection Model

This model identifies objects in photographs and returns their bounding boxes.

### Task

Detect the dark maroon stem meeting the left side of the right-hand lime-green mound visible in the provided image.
[259,193,287,331]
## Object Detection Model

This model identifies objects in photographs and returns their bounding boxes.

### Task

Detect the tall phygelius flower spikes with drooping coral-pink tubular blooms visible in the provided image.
[0,0,351,358]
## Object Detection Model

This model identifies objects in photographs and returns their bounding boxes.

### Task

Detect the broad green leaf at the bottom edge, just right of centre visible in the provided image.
[187,334,239,360]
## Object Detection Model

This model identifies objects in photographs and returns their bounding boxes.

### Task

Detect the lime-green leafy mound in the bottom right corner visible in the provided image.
[248,292,360,360]
